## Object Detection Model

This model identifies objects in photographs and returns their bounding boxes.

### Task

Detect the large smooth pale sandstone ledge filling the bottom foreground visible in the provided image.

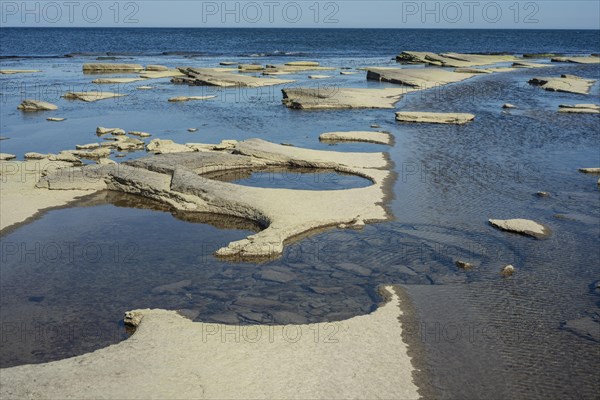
[0,286,420,400]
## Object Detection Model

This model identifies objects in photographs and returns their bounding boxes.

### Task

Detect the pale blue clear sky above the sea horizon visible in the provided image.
[0,0,600,29]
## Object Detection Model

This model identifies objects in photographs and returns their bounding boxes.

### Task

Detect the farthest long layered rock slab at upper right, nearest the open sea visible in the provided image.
[396,51,519,68]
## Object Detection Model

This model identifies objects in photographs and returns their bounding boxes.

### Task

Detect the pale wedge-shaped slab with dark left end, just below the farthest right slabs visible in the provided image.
[367,68,473,89]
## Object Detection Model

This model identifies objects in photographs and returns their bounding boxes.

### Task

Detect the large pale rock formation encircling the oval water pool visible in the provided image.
[108,139,392,259]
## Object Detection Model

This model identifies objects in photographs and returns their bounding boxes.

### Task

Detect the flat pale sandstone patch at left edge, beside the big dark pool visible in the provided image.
[0,159,90,231]
